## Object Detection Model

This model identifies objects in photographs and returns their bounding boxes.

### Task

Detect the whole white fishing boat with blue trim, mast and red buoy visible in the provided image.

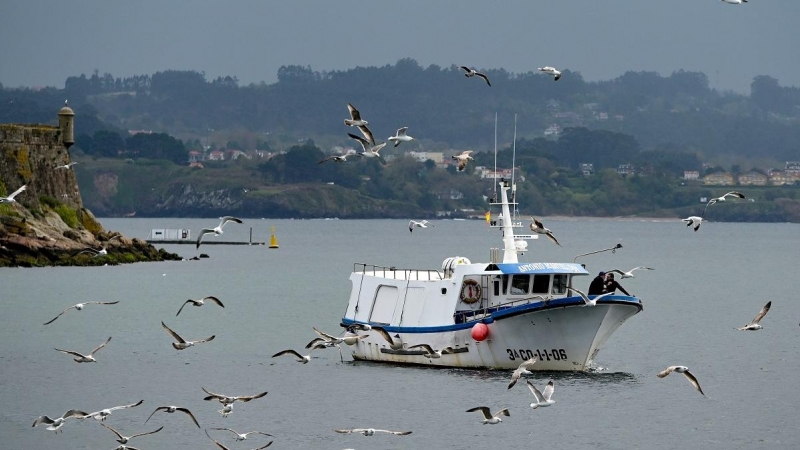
[341,180,642,371]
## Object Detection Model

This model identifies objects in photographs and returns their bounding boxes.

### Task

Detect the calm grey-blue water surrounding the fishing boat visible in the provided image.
[0,219,800,450]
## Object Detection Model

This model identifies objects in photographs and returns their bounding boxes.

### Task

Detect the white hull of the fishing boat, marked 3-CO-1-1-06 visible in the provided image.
[350,297,642,371]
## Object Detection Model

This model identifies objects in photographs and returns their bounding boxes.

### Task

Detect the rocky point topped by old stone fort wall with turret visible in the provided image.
[0,106,181,267]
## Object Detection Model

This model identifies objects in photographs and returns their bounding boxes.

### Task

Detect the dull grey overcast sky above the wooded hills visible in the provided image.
[0,0,800,93]
